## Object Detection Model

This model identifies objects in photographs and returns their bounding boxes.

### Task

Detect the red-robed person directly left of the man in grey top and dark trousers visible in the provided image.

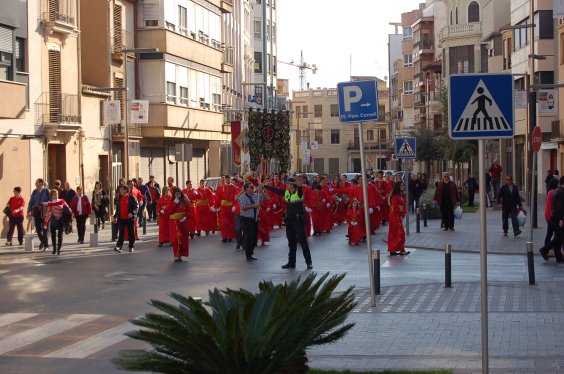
[215,175,237,243]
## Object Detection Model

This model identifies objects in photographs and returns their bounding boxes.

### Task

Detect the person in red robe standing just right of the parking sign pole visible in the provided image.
[388,182,410,256]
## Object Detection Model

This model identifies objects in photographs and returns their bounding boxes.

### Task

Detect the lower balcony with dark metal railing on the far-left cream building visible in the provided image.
[35,92,82,124]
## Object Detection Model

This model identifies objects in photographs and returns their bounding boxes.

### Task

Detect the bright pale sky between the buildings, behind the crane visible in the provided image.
[276,0,425,92]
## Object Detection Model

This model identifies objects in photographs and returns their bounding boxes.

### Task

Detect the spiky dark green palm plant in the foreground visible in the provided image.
[114,273,356,374]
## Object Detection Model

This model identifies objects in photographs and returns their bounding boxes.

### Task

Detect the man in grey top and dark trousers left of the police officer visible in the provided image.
[238,182,260,262]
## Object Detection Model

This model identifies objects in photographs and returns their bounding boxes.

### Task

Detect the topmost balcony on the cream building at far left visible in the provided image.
[41,0,78,39]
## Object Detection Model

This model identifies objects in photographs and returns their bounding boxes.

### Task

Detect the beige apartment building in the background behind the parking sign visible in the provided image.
[290,77,392,174]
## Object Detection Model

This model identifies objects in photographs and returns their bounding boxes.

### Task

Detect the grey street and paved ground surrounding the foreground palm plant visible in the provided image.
[0,209,564,373]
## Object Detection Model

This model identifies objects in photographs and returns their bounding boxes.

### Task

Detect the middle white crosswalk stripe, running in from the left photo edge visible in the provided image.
[0,314,102,354]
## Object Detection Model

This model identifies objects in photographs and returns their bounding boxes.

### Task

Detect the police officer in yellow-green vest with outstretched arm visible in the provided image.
[264,178,313,269]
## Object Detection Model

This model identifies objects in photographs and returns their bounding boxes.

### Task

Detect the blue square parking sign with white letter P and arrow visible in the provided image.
[337,80,378,122]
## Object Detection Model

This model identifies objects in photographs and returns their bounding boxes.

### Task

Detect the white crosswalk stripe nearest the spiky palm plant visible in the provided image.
[43,322,135,358]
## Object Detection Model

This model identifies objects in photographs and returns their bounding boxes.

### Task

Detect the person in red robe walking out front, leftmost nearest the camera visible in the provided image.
[167,188,193,262]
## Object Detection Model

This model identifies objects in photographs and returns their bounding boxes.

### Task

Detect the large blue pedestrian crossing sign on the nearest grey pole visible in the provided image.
[448,74,515,139]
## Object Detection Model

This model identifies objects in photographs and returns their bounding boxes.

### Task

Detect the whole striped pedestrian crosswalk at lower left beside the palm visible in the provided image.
[0,313,140,359]
